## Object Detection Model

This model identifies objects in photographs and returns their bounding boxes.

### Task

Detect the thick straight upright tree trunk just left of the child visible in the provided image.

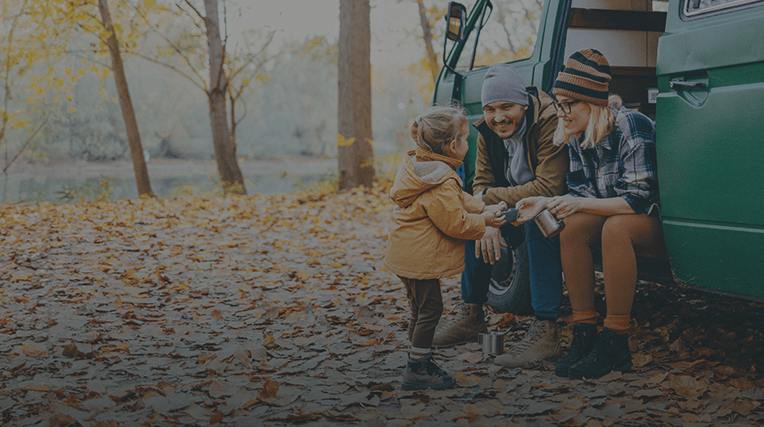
[337,0,374,189]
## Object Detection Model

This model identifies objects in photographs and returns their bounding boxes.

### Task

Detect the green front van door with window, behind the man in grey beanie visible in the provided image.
[433,0,570,189]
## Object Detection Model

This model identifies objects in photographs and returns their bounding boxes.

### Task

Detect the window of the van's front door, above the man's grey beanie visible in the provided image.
[457,0,544,71]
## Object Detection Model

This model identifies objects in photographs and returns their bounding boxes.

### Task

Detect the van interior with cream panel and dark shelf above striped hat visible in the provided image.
[565,0,667,119]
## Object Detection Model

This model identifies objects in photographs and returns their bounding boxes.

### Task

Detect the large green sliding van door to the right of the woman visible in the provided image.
[656,0,764,298]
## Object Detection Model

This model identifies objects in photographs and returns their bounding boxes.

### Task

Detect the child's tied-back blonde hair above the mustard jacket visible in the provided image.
[410,107,467,154]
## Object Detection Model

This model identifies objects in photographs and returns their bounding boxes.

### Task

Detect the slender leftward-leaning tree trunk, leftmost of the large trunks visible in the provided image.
[98,0,154,196]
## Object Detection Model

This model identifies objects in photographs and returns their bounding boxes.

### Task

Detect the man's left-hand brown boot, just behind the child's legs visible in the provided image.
[432,304,488,348]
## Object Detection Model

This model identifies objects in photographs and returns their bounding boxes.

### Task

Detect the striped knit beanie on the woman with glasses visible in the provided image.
[553,49,611,106]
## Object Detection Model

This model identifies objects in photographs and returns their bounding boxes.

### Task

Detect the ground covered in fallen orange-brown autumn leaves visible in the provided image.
[0,184,764,426]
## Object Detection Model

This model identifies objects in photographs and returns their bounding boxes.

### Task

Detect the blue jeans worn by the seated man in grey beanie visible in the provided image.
[462,222,562,320]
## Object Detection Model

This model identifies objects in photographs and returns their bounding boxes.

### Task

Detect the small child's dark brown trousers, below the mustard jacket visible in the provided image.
[399,276,443,348]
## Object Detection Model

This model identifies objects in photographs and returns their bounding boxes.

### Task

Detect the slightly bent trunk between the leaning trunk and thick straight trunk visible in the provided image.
[204,0,246,194]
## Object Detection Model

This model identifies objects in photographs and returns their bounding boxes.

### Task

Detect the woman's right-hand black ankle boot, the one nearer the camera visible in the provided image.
[568,328,631,378]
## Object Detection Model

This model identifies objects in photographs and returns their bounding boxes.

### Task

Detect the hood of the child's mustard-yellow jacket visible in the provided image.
[390,149,462,208]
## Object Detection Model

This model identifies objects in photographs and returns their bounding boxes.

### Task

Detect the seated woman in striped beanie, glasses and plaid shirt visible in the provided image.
[518,49,664,378]
